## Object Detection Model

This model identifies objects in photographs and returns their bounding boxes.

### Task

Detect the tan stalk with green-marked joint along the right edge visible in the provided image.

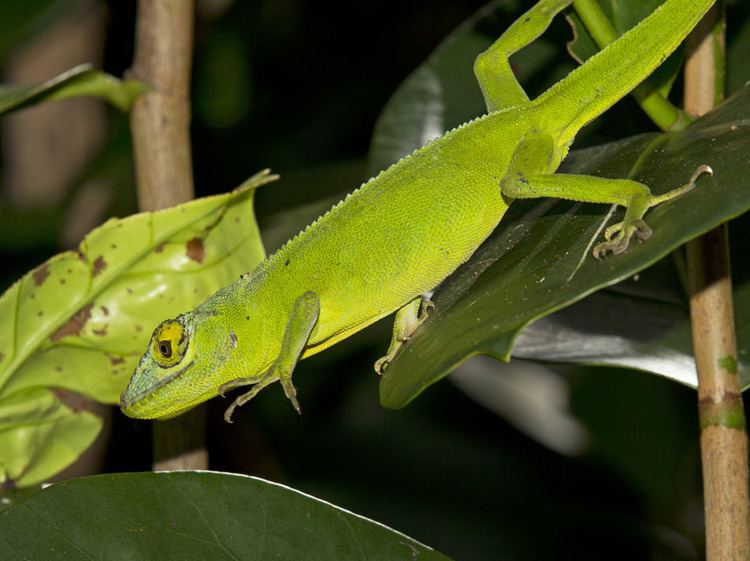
[685,6,750,561]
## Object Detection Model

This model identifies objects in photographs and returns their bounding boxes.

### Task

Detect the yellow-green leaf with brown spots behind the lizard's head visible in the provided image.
[0,172,275,486]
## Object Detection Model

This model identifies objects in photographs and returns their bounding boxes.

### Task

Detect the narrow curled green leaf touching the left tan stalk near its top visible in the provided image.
[0,64,149,115]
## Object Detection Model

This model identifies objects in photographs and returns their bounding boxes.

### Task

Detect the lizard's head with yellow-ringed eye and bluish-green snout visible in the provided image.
[120,311,231,419]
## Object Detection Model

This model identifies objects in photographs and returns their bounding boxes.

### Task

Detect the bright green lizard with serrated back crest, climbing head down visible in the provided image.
[121,0,713,421]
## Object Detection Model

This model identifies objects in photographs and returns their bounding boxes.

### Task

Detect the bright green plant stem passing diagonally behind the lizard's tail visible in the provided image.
[573,0,691,131]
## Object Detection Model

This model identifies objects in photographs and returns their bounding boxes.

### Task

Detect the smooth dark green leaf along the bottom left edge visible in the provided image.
[0,472,448,561]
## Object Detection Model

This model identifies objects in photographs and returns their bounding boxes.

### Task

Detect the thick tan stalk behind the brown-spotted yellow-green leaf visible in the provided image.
[130,0,208,471]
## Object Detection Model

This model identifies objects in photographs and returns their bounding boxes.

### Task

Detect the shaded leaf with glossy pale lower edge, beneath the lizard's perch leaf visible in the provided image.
[513,213,750,389]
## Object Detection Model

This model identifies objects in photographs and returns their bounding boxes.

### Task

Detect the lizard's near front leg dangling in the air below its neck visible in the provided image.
[219,292,320,423]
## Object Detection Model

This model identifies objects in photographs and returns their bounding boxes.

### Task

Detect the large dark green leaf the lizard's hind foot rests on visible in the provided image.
[380,88,750,407]
